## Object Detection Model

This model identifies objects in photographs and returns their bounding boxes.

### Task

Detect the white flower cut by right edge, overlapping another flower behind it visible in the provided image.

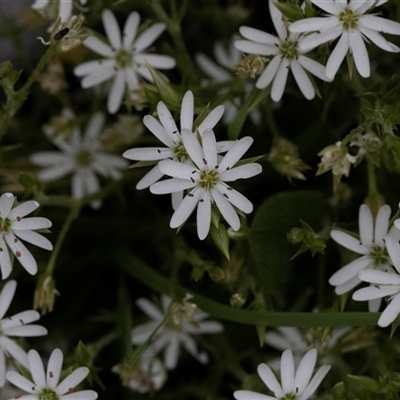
[353,234,400,328]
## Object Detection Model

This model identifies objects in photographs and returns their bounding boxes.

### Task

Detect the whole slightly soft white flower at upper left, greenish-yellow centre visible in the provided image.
[74,10,175,114]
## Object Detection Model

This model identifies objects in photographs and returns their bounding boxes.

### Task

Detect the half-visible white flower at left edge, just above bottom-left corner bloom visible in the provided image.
[0,281,47,388]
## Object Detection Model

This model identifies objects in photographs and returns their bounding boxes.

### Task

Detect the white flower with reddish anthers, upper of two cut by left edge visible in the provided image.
[0,193,53,279]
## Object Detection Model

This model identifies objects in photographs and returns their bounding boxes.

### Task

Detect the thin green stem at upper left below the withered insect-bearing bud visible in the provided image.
[0,44,57,139]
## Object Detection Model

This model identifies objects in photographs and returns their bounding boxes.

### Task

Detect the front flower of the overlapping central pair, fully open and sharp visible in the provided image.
[150,129,262,240]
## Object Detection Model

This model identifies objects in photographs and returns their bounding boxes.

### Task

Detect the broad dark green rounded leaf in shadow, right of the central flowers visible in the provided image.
[250,191,326,295]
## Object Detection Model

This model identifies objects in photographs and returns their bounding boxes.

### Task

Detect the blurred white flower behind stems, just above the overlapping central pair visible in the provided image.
[196,42,261,125]
